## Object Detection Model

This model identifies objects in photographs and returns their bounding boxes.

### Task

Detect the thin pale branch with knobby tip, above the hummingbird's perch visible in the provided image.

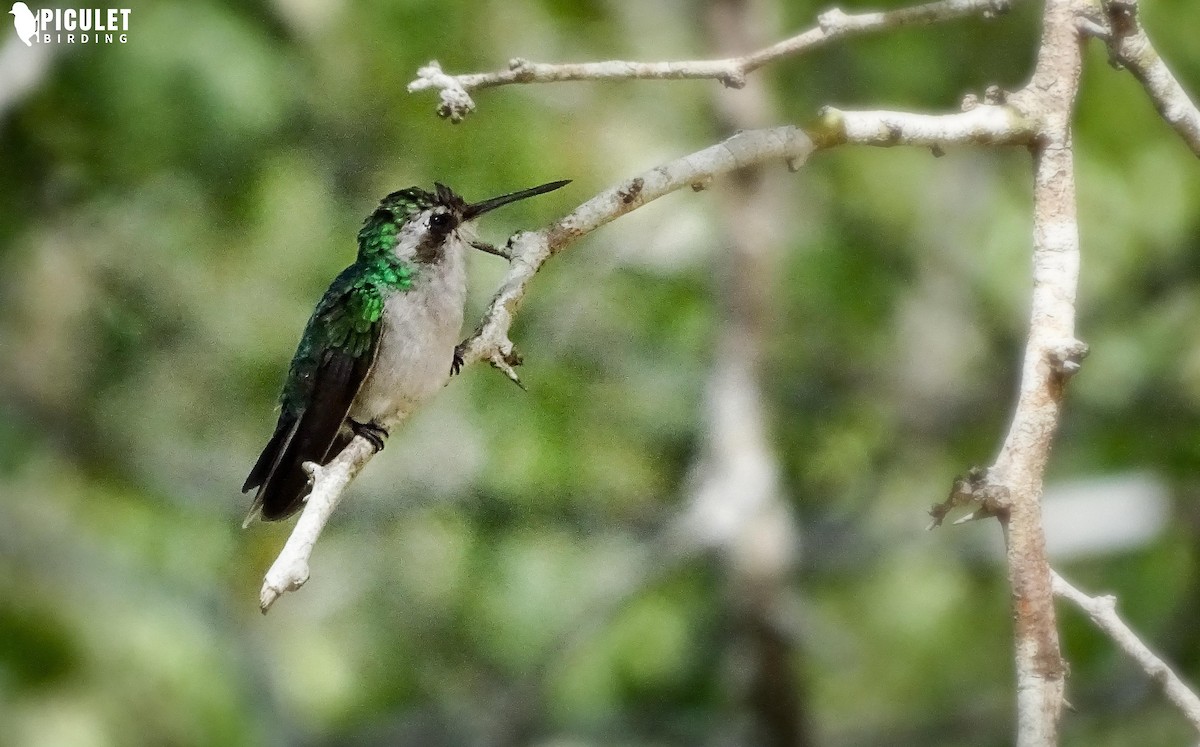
[408,0,1012,122]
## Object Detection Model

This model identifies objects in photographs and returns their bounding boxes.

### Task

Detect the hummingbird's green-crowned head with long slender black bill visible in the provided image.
[359,181,570,264]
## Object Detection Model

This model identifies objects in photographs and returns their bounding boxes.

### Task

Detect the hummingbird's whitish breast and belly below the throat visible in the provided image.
[350,251,467,428]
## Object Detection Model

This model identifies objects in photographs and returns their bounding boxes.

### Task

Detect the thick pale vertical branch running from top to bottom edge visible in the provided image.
[989,0,1081,747]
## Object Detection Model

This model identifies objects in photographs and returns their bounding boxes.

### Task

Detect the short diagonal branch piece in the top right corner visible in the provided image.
[1093,0,1200,156]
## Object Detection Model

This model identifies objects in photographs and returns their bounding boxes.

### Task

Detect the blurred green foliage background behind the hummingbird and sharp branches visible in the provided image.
[0,0,1200,747]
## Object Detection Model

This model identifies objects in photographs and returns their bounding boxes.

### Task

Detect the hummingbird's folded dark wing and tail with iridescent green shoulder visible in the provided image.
[242,270,384,522]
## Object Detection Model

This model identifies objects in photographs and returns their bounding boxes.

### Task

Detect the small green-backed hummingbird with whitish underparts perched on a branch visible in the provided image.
[241,181,570,526]
